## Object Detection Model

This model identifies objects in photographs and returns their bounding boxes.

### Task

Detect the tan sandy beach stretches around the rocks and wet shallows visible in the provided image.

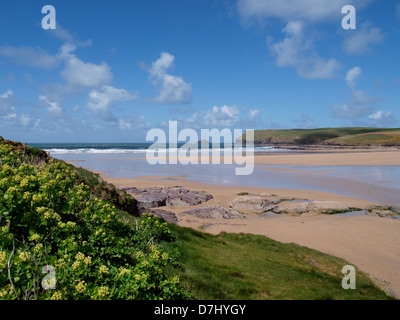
[102,150,400,298]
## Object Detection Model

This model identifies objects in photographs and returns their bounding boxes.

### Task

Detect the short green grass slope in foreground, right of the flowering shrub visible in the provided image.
[165,226,391,300]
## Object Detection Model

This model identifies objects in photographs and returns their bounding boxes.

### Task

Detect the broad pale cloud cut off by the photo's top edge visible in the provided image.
[237,0,371,22]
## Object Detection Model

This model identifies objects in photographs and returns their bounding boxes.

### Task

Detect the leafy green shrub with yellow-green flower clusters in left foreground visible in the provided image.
[0,145,190,300]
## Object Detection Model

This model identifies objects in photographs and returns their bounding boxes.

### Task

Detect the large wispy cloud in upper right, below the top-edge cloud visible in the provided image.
[269,21,340,79]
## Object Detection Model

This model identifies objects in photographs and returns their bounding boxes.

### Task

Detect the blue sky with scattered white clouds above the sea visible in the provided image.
[0,0,400,143]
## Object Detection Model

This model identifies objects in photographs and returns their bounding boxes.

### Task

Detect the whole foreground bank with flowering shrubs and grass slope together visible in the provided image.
[0,139,390,300]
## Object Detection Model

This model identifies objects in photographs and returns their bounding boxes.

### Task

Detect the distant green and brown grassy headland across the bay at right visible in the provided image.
[242,127,400,146]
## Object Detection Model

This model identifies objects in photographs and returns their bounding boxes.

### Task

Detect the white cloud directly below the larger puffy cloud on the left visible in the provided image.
[86,86,137,119]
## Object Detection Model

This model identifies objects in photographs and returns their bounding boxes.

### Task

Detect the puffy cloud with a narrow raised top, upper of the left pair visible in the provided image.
[59,44,113,88]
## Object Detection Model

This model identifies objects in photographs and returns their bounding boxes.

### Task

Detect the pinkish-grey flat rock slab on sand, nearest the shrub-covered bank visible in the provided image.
[121,186,213,208]
